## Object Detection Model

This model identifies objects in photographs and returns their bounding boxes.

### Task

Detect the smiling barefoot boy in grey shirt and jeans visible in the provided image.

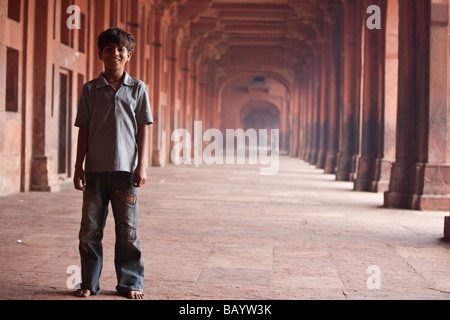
[74,28,153,299]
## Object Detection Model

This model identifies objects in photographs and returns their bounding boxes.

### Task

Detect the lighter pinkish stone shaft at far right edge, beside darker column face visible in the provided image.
[420,0,450,211]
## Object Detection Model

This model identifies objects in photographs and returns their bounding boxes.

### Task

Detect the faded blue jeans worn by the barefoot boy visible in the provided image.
[79,171,144,294]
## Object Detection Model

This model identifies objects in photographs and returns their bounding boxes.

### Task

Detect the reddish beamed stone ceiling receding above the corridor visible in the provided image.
[162,0,341,77]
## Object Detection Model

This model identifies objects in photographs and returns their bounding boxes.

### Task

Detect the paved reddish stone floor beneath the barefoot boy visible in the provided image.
[0,157,450,300]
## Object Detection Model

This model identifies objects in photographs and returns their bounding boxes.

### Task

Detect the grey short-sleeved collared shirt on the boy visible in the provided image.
[75,72,153,172]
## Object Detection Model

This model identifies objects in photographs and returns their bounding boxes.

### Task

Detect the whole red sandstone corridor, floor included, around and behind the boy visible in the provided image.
[0,0,450,300]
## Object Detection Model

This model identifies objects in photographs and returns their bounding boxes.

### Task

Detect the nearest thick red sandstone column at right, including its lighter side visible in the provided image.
[384,0,450,210]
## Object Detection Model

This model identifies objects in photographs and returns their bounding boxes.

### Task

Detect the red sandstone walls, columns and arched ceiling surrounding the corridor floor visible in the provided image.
[0,0,450,210]
